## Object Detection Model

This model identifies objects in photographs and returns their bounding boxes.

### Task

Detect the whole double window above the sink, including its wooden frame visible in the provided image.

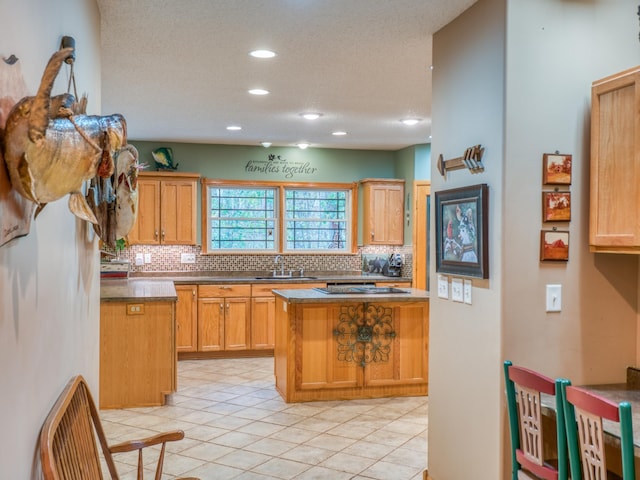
[202,180,357,253]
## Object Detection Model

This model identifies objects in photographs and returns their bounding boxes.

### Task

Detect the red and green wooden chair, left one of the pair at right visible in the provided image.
[504,360,568,480]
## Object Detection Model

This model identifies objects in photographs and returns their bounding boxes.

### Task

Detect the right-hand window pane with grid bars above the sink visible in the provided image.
[284,188,349,252]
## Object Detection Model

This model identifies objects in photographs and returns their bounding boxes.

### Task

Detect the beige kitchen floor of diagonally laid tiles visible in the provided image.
[100,358,428,480]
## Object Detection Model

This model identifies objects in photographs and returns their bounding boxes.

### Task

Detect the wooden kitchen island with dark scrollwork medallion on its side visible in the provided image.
[273,288,429,402]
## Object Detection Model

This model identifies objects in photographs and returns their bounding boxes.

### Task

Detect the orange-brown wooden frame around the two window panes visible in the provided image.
[200,178,358,255]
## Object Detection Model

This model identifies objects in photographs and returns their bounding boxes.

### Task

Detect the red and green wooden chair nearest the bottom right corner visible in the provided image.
[561,380,636,480]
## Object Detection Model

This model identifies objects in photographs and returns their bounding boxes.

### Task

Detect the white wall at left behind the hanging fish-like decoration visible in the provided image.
[0,0,100,479]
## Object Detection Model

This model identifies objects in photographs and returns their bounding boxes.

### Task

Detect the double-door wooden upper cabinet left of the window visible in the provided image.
[129,172,200,245]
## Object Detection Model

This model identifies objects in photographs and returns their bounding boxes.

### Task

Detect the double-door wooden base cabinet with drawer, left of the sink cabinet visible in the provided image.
[197,284,251,352]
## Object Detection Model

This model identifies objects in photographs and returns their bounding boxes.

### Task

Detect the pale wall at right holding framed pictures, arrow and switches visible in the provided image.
[428,0,640,480]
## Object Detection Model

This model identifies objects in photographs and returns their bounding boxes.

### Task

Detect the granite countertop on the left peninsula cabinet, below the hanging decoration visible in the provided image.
[100,278,178,302]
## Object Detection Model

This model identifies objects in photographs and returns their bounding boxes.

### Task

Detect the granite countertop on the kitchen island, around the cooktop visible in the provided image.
[273,288,429,303]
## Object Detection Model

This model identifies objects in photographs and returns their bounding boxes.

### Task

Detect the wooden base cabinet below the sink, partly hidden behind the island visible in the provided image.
[251,283,327,350]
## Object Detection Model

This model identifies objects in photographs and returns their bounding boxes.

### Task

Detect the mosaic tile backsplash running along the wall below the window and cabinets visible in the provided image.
[107,245,412,278]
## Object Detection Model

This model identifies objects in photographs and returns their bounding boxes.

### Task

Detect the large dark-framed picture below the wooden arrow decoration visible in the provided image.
[435,183,489,278]
